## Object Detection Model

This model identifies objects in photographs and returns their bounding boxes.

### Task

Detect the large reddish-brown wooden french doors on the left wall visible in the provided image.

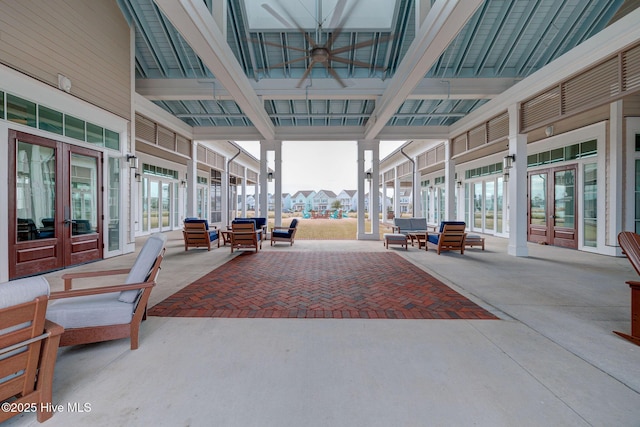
[8,131,102,279]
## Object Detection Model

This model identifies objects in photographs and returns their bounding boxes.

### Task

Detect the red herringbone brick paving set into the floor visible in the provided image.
[149,252,496,319]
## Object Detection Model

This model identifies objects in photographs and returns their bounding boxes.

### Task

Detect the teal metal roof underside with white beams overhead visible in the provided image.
[118,0,624,139]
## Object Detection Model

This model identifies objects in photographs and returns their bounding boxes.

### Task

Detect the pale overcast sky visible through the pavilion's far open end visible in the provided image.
[237,141,405,194]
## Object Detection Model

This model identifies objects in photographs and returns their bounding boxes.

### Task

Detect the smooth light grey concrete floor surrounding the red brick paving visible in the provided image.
[6,232,640,427]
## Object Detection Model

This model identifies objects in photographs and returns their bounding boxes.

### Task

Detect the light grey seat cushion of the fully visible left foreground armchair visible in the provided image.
[47,292,135,329]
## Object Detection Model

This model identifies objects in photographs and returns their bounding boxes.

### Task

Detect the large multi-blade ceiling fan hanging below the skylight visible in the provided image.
[252,0,393,88]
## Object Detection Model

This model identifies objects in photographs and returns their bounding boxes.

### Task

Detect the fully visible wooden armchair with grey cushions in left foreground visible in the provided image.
[47,233,167,350]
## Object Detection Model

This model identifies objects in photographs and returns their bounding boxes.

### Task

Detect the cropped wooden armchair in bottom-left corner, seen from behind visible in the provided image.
[0,276,63,423]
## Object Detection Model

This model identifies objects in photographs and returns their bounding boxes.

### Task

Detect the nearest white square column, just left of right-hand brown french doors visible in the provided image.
[507,104,529,257]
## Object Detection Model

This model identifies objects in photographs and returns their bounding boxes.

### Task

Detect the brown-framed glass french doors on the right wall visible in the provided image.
[527,165,578,249]
